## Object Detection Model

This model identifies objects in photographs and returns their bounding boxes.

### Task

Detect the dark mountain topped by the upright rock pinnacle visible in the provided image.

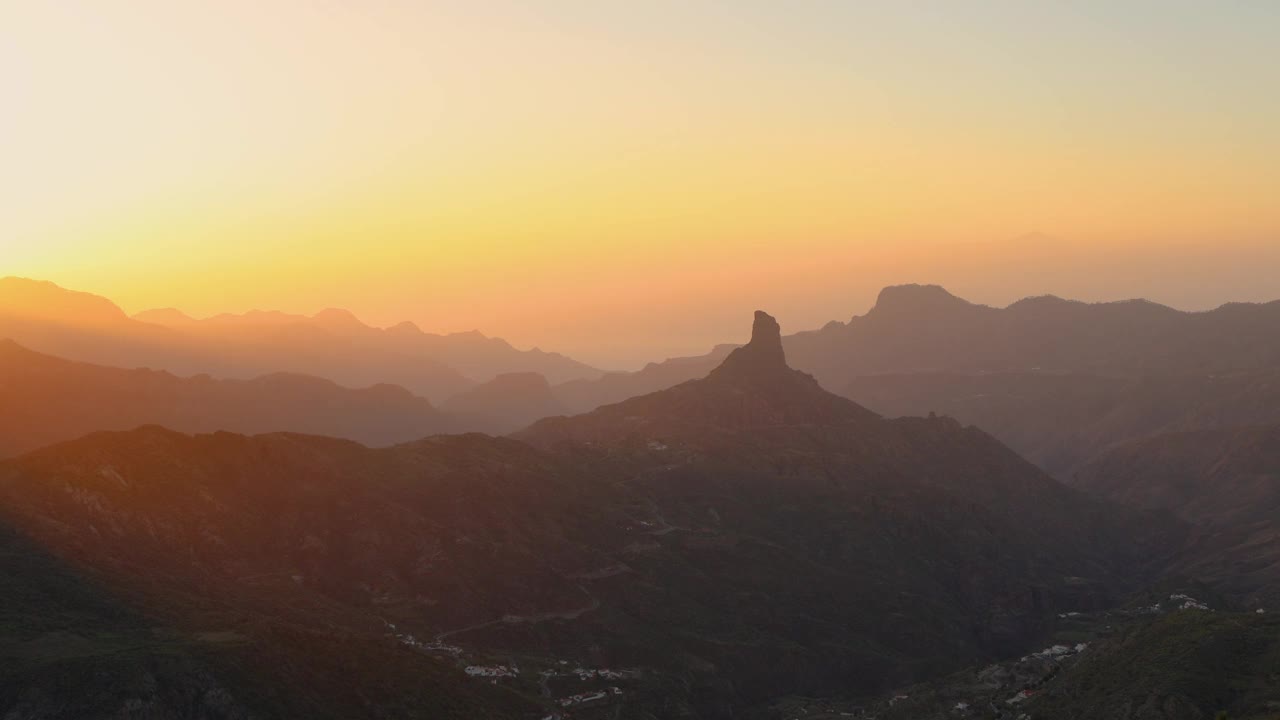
[516,315,1167,691]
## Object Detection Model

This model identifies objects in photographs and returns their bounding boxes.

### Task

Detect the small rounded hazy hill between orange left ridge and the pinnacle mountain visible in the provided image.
[444,373,564,434]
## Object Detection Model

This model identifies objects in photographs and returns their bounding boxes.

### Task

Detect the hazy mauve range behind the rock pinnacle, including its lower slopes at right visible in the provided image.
[542,286,1280,478]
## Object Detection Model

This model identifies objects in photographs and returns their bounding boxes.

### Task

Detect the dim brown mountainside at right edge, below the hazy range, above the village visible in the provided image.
[1073,424,1280,602]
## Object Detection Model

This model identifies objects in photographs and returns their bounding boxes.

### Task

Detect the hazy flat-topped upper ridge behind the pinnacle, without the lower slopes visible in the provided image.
[556,284,1280,411]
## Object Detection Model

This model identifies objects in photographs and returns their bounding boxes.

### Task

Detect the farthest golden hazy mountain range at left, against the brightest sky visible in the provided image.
[0,278,600,401]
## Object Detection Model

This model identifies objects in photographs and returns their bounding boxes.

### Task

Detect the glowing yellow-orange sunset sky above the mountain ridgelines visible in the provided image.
[0,0,1280,368]
